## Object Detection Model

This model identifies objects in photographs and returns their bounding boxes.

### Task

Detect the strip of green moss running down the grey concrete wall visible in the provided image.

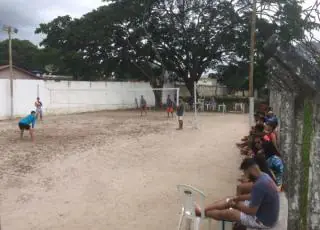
[299,100,313,230]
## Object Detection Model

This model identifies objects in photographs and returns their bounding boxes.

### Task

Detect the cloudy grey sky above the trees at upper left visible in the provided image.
[0,0,314,44]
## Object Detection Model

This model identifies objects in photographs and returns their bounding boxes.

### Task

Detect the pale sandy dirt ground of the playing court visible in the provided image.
[0,112,248,230]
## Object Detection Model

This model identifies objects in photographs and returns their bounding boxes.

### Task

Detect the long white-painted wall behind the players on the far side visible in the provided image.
[0,79,176,119]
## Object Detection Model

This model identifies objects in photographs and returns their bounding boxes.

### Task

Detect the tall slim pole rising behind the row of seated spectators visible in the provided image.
[249,0,257,127]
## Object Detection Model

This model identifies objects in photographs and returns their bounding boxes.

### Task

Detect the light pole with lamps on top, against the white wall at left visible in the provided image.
[2,25,18,119]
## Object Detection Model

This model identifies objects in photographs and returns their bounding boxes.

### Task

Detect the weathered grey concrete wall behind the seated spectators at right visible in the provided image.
[265,36,320,230]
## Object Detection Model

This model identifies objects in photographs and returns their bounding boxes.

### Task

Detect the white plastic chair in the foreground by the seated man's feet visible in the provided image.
[177,184,211,230]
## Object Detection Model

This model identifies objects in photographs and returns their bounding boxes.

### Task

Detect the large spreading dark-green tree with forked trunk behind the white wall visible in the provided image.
[36,0,240,94]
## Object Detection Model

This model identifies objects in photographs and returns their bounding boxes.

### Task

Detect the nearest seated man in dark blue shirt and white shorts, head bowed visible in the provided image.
[196,158,280,229]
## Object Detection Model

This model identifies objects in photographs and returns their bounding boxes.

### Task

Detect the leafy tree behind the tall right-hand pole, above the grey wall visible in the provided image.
[219,0,319,89]
